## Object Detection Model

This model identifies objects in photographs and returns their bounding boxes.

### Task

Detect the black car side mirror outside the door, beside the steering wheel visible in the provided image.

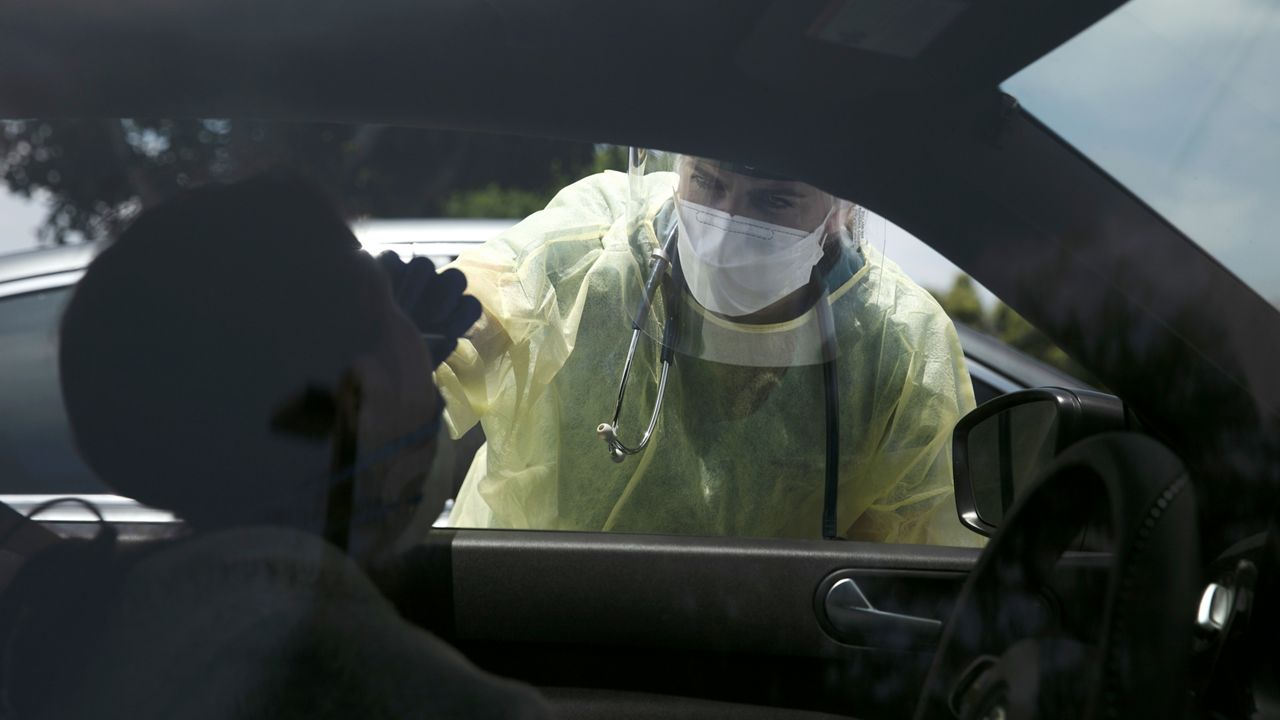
[951,387,1129,537]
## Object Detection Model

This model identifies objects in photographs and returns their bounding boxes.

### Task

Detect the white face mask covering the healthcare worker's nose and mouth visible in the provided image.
[676,199,831,316]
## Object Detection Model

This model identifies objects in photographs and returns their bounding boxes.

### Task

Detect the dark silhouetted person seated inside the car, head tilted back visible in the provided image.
[4,174,545,719]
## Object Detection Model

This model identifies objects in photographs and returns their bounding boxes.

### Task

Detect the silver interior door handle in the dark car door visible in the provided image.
[823,578,942,650]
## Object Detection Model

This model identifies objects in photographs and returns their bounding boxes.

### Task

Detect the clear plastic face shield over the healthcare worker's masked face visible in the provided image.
[596,149,865,471]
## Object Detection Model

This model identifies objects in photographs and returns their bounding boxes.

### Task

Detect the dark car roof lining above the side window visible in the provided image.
[0,0,1117,163]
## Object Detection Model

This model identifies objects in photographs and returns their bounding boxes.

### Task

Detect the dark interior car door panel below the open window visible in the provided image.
[388,529,979,716]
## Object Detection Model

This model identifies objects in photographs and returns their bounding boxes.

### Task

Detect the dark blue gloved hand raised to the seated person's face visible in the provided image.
[378,250,480,368]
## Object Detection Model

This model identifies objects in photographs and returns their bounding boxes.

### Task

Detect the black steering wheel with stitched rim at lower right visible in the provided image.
[915,433,1201,720]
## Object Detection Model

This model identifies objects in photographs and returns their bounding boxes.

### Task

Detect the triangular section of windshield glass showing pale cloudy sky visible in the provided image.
[1004,0,1280,306]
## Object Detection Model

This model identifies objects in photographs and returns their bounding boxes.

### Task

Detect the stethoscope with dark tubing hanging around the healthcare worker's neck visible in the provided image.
[595,223,840,539]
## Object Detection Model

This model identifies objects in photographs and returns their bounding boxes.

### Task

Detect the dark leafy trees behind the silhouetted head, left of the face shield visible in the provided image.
[0,119,625,243]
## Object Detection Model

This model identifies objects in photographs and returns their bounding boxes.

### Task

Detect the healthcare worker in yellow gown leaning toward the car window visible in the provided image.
[436,149,978,544]
